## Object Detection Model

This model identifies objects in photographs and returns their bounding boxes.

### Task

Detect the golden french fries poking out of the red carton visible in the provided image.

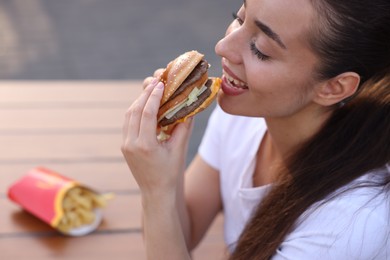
[57,186,112,233]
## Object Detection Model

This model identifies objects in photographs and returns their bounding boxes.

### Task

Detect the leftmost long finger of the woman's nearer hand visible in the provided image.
[125,80,157,140]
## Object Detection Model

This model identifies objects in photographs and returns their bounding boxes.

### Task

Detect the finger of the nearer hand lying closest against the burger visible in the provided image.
[139,82,164,142]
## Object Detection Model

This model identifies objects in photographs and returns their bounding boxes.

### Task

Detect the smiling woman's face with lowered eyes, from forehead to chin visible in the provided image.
[215,0,317,117]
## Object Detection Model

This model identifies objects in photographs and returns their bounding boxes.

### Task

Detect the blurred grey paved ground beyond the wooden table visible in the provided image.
[0,0,242,162]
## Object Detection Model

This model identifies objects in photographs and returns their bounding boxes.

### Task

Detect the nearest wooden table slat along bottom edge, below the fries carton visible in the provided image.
[0,233,146,260]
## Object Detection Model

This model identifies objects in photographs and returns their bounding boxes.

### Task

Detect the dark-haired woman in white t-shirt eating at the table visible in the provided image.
[122,0,390,259]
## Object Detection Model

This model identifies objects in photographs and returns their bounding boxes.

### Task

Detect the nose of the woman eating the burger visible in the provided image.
[215,24,243,64]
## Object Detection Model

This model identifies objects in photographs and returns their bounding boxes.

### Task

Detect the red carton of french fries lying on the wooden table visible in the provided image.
[8,167,111,236]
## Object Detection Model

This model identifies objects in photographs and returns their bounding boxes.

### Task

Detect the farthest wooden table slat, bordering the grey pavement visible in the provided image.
[0,81,142,102]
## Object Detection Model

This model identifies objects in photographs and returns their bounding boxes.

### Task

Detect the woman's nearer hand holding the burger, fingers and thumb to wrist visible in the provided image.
[122,79,192,197]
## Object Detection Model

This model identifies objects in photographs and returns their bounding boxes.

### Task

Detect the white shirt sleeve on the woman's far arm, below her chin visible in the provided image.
[198,105,223,170]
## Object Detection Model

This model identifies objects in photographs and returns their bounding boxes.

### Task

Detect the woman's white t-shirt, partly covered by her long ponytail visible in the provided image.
[199,106,390,260]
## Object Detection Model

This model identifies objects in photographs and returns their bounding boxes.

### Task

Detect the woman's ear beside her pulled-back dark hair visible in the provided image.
[314,72,360,106]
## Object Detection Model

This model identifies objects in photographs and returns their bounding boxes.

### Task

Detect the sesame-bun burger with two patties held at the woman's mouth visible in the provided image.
[157,51,221,140]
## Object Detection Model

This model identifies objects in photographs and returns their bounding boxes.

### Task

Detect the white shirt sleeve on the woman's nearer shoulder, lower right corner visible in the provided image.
[272,198,390,260]
